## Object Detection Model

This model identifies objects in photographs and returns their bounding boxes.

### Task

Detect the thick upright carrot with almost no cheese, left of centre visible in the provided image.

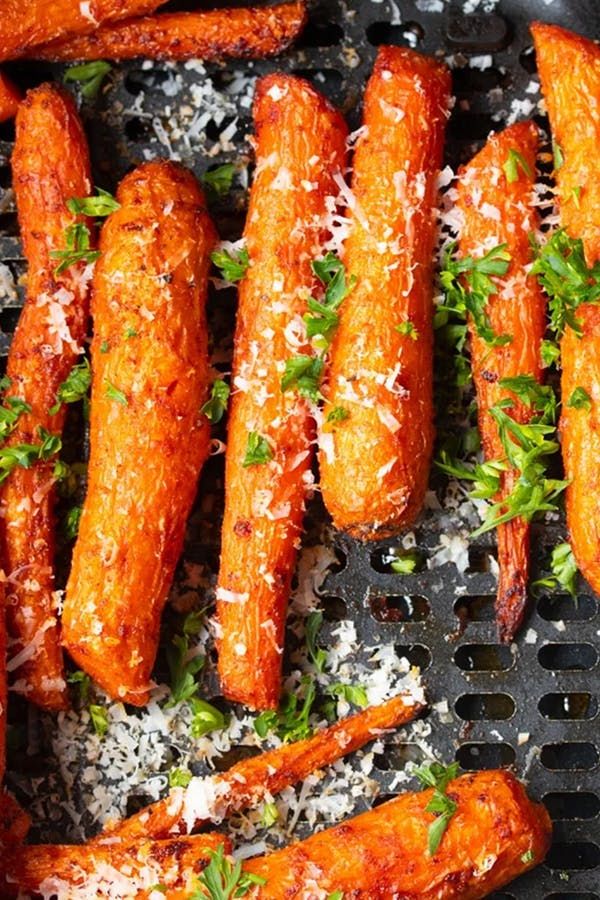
[63,161,216,706]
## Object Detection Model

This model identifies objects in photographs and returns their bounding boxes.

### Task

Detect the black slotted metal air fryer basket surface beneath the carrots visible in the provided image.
[0,0,600,900]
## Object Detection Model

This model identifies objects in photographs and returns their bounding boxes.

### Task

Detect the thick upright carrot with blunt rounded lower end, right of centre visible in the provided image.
[320,47,450,539]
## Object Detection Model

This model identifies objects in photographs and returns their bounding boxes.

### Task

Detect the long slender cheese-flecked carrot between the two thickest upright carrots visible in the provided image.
[217,75,347,709]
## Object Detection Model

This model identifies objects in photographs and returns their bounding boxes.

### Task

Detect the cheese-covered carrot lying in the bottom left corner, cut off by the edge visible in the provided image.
[0,834,231,900]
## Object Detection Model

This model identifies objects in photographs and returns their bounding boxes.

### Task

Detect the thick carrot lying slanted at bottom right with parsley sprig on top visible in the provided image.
[244,770,552,900]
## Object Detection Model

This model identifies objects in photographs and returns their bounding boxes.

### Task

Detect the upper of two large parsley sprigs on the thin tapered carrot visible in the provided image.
[437,243,512,347]
